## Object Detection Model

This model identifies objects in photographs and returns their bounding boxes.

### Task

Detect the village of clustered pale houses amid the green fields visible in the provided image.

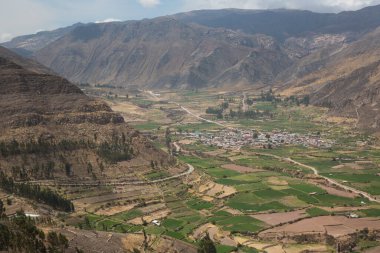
[182,129,334,150]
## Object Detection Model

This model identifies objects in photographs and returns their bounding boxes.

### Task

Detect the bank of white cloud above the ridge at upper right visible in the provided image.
[184,0,380,12]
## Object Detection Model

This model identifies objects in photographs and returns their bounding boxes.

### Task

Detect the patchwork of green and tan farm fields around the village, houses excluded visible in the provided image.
[73,88,380,252]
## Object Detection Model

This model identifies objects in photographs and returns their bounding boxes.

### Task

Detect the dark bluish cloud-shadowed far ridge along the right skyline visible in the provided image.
[173,5,380,41]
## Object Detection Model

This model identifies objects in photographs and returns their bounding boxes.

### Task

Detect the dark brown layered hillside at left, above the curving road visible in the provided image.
[0,48,170,181]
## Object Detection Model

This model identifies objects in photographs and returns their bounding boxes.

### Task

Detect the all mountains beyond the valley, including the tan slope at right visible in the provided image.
[4,6,380,129]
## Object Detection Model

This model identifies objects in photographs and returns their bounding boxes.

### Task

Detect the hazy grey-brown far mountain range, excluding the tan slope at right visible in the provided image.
[4,6,380,89]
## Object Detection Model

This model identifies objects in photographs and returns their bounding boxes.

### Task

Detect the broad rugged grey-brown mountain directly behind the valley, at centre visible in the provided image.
[35,18,291,88]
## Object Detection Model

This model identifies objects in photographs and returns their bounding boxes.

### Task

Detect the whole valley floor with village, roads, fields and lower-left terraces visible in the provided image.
[5,89,380,253]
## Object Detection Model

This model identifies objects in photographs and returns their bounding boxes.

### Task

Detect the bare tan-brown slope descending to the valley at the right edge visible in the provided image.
[277,28,380,130]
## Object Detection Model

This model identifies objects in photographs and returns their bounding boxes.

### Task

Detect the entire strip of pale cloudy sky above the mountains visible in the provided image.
[0,0,380,42]
